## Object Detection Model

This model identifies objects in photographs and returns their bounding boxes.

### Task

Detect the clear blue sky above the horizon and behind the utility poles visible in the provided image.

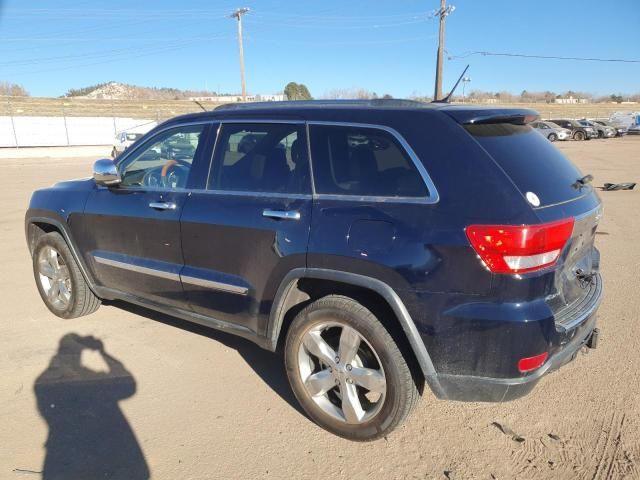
[0,0,640,97]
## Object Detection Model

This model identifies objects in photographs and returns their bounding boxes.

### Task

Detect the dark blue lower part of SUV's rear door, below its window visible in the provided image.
[182,193,311,331]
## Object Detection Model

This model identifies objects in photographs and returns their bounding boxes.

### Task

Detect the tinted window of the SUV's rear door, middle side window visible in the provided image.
[208,122,311,194]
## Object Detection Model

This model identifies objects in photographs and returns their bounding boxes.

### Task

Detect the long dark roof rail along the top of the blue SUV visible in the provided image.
[215,98,428,110]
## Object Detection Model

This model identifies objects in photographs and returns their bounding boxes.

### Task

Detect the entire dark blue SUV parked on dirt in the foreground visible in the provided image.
[25,100,602,440]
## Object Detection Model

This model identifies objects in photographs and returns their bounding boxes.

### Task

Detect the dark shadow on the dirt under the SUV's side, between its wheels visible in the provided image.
[110,301,306,417]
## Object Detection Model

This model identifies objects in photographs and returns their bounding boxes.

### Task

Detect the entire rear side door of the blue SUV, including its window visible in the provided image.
[181,122,312,333]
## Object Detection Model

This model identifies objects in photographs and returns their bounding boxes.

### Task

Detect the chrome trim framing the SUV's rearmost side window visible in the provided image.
[307,120,440,204]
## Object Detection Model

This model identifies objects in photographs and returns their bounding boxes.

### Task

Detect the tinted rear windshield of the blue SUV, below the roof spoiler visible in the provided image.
[465,123,591,206]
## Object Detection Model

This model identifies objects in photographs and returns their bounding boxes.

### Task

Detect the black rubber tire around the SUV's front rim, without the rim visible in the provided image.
[32,232,100,318]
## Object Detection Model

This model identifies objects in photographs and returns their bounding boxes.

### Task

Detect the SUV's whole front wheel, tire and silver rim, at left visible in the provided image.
[33,232,100,318]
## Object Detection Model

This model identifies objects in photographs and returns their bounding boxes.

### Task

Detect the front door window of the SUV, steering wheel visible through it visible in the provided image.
[119,125,205,189]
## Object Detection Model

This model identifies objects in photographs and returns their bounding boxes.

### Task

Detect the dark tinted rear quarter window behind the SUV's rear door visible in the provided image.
[310,125,428,197]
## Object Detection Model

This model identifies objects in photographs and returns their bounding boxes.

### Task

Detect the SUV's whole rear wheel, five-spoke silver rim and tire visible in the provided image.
[285,295,419,441]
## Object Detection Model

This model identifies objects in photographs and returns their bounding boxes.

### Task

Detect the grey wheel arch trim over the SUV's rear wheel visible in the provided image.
[266,268,440,396]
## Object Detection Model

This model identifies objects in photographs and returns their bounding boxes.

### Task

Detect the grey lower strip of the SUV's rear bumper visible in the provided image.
[437,309,596,402]
